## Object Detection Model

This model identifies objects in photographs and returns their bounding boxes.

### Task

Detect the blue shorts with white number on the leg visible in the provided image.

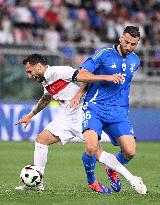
[82,108,134,146]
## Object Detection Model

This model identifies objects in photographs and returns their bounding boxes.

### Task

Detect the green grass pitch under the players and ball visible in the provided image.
[0,142,160,205]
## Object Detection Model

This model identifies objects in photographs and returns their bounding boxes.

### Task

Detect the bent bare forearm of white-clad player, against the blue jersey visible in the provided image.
[70,83,87,108]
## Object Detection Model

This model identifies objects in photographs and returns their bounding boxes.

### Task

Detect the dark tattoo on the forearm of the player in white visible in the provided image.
[32,95,52,115]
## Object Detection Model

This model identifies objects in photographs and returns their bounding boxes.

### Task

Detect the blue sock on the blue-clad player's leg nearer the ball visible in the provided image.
[82,152,96,184]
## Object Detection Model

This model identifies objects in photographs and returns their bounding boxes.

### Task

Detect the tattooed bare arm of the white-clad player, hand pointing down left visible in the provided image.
[15,94,52,128]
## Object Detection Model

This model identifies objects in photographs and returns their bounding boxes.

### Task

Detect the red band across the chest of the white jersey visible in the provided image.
[45,80,69,95]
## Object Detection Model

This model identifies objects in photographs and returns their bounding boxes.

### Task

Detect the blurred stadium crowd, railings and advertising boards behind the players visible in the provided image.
[0,0,160,141]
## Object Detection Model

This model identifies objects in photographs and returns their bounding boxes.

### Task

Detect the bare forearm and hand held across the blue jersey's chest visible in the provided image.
[76,68,123,84]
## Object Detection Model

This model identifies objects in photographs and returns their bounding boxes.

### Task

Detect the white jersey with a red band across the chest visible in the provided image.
[42,66,79,106]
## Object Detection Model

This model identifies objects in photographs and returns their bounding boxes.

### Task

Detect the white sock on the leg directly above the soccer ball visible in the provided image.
[34,142,48,175]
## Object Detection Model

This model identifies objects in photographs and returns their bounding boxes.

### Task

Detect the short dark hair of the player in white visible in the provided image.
[23,53,48,65]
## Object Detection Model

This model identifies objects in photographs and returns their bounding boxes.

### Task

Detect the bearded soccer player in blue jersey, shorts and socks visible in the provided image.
[73,26,144,192]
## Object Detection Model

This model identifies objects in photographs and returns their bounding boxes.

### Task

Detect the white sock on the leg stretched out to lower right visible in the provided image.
[99,151,133,181]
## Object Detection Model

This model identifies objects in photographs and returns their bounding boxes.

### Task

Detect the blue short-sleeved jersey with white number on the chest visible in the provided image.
[81,45,140,119]
